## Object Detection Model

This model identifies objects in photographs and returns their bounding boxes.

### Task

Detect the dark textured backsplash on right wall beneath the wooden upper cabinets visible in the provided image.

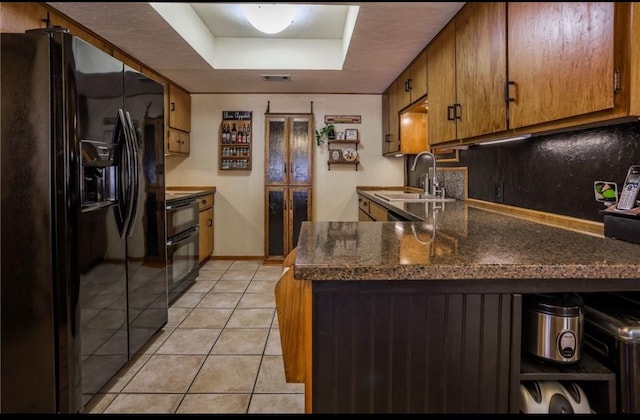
[407,122,640,222]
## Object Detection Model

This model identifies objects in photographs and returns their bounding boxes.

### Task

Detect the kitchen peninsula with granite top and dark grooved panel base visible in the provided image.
[293,191,640,413]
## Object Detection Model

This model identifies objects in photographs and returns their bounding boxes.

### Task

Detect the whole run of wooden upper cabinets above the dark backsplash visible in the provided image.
[390,2,640,149]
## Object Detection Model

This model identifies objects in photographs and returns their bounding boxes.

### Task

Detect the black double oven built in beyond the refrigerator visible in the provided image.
[167,193,200,302]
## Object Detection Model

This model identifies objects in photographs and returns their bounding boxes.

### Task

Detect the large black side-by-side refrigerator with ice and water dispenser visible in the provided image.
[0,28,168,413]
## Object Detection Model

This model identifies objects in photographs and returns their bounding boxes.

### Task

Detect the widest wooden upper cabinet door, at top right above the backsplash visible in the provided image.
[507,2,615,128]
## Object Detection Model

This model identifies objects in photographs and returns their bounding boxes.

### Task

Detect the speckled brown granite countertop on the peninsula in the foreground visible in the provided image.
[294,194,640,291]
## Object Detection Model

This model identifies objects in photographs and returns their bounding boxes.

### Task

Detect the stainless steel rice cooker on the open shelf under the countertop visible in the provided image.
[522,293,584,363]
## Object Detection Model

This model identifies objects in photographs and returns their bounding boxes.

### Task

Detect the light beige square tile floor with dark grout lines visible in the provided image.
[85,260,304,414]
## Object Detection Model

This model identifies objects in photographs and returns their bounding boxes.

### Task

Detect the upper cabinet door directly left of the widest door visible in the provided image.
[455,2,508,139]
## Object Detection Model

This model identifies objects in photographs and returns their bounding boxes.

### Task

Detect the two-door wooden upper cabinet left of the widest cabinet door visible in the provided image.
[427,2,507,146]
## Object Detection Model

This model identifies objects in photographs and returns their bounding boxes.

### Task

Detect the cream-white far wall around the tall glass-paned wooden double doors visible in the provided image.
[166,94,404,257]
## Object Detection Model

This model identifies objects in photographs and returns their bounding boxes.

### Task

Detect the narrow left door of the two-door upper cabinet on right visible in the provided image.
[427,23,458,146]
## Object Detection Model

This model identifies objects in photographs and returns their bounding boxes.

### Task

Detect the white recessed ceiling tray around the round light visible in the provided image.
[151,3,359,70]
